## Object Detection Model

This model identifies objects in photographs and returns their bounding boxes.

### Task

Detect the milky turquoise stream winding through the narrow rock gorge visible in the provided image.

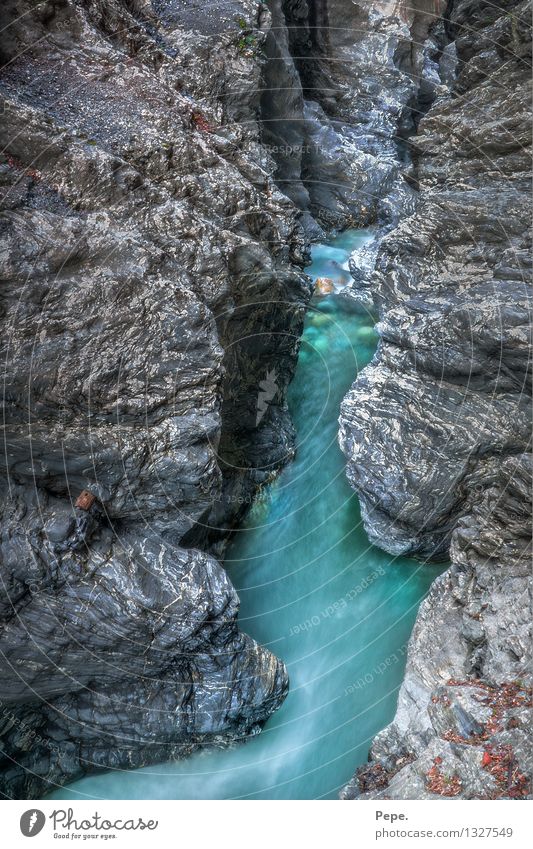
[50,231,437,799]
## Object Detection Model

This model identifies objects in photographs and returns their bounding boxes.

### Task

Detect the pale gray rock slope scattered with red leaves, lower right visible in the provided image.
[341,454,533,799]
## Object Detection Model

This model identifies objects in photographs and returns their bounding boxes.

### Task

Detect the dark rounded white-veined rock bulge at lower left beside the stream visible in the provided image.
[0,488,287,798]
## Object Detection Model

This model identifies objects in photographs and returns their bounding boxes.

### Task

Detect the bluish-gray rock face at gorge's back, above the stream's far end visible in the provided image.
[262,0,446,236]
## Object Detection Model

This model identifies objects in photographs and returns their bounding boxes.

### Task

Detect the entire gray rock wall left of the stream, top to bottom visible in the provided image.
[0,0,310,798]
